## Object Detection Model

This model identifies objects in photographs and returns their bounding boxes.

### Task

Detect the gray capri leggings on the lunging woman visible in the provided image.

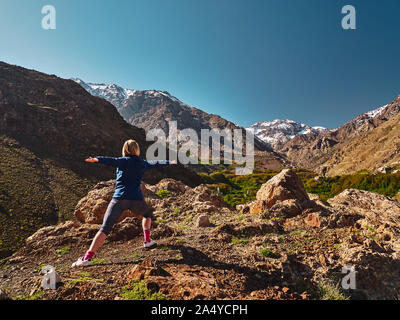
[100,198,153,235]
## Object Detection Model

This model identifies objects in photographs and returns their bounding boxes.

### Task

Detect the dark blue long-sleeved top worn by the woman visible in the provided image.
[96,156,169,200]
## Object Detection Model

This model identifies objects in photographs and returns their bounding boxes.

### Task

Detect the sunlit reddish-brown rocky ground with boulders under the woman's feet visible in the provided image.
[0,170,400,300]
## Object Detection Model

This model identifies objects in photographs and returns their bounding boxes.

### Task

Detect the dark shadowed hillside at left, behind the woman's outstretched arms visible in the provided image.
[0,62,200,257]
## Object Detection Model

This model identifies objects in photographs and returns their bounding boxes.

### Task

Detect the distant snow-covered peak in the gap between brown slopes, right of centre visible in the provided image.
[247,119,327,149]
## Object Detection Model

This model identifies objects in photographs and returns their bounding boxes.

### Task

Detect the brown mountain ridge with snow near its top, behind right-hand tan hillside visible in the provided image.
[277,96,400,169]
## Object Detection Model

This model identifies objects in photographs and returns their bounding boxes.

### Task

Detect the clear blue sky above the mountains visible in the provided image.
[0,0,400,128]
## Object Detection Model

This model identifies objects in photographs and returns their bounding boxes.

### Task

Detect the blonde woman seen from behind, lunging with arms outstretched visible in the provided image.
[72,140,169,267]
